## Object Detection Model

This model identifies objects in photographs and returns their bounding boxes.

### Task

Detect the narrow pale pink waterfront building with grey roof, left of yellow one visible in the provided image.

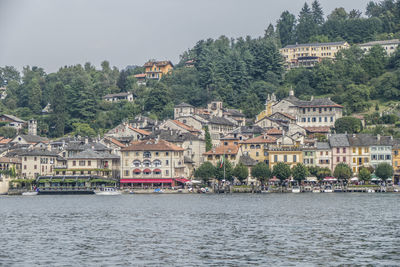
[329,134,350,172]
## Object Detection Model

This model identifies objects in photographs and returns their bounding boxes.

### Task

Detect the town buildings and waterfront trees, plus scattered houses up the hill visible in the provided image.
[0,40,400,194]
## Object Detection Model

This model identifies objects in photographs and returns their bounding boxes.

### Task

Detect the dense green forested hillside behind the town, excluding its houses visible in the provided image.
[0,0,400,137]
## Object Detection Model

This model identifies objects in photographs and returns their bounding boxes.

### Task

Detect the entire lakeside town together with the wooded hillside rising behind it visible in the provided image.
[0,1,400,194]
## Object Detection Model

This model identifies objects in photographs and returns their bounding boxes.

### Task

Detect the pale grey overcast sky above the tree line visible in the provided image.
[0,0,369,72]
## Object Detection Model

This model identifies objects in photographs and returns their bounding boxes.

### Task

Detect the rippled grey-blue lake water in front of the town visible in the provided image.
[0,193,400,266]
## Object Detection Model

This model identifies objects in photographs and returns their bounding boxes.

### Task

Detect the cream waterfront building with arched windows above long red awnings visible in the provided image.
[120,139,185,185]
